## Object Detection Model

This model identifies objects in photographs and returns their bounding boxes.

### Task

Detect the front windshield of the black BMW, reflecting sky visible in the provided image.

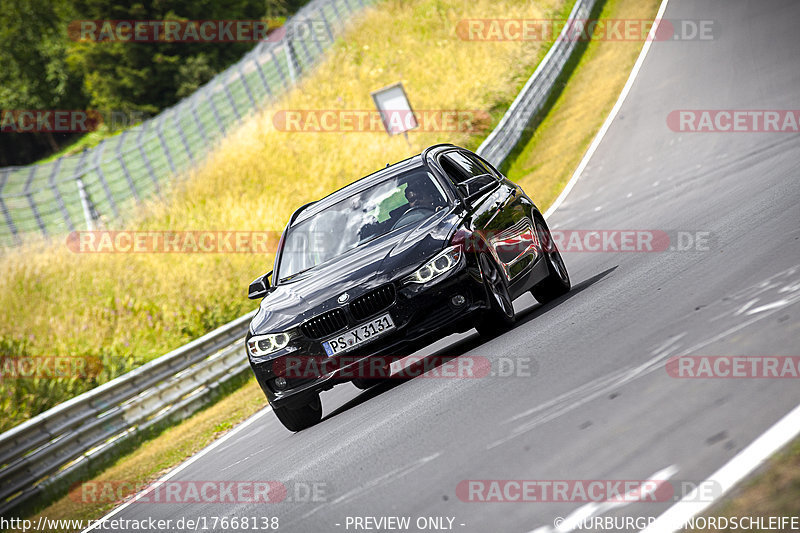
[276,167,447,281]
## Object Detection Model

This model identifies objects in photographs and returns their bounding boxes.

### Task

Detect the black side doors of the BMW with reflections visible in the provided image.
[439,150,537,290]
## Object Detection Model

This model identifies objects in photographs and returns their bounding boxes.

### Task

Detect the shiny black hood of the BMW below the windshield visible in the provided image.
[250,210,459,334]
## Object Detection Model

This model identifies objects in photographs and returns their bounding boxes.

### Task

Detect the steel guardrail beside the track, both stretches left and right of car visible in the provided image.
[0,0,595,516]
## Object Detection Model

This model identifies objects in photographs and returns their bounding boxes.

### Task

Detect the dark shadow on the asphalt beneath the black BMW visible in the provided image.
[322,265,619,420]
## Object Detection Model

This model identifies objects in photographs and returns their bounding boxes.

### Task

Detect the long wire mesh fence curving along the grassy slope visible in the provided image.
[0,0,375,246]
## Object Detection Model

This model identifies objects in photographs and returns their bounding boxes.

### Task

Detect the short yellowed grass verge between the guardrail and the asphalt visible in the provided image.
[7,0,676,518]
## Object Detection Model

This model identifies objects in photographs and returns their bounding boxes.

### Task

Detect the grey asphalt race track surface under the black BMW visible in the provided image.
[97,0,800,533]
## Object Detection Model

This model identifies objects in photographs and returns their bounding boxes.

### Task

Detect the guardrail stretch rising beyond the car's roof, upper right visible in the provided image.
[477,0,596,166]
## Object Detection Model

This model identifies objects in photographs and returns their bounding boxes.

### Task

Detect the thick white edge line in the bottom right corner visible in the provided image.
[642,405,800,533]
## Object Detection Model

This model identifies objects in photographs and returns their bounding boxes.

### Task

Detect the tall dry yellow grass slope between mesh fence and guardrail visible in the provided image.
[0,0,569,429]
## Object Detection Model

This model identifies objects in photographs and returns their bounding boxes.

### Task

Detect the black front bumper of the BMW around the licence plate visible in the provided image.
[248,263,487,407]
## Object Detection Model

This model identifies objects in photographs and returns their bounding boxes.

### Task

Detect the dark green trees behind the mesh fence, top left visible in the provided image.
[0,0,307,166]
